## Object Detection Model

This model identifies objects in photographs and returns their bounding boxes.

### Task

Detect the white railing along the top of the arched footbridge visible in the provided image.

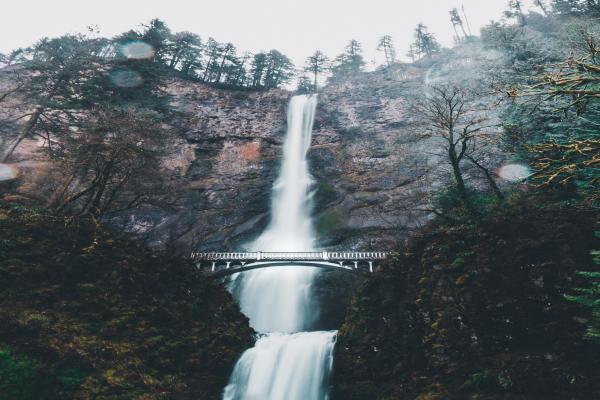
[192,251,388,261]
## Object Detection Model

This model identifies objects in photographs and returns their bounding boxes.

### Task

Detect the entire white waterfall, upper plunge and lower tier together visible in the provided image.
[223,95,336,400]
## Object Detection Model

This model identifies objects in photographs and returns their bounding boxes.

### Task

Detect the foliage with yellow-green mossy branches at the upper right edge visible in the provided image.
[508,23,600,203]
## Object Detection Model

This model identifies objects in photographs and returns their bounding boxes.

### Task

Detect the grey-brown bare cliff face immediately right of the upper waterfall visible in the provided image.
[310,66,428,250]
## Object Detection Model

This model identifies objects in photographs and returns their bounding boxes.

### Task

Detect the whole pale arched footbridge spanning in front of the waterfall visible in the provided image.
[192,251,388,277]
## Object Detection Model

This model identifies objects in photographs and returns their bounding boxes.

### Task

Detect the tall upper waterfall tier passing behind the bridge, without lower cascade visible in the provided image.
[232,95,319,333]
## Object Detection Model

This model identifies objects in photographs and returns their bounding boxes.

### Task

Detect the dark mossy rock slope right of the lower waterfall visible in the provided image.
[332,199,600,400]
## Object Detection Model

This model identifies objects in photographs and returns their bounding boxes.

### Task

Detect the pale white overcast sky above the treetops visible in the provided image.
[0,0,540,65]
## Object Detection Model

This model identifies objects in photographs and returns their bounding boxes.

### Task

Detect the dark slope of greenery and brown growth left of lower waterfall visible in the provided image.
[0,203,252,400]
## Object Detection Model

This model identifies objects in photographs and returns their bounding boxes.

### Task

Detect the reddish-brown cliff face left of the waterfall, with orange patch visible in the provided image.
[151,82,290,250]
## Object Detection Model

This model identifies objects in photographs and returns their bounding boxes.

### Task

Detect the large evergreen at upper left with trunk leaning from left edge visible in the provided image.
[0,35,110,162]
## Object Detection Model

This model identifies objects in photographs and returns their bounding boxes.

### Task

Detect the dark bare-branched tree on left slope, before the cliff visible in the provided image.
[52,109,168,219]
